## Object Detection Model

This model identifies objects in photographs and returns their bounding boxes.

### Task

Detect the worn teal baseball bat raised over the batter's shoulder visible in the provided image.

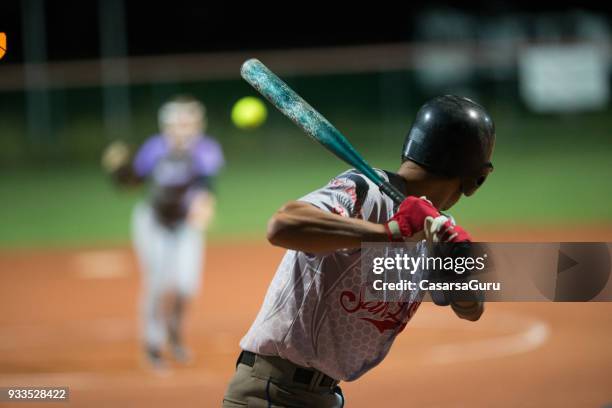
[240,58,405,204]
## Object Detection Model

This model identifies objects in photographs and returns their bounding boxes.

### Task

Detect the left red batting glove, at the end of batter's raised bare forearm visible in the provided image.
[384,196,440,241]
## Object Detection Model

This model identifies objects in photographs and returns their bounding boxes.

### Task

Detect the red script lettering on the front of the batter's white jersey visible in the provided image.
[340,288,420,334]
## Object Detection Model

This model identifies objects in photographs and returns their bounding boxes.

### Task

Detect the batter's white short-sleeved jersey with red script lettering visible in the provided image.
[240,170,423,381]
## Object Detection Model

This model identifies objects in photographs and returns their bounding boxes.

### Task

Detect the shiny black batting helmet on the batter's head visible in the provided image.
[402,95,495,196]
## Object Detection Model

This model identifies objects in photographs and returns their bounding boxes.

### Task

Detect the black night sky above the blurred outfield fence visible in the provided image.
[0,0,611,62]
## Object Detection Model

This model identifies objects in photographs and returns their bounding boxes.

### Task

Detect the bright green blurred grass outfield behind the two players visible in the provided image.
[0,148,612,247]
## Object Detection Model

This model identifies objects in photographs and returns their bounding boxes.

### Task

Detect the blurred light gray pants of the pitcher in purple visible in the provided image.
[132,203,204,350]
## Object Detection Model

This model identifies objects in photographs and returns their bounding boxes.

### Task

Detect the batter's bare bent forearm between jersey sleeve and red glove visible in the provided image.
[268,202,388,253]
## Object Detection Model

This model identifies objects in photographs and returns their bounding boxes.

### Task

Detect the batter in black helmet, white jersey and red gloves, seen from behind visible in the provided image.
[223,95,495,407]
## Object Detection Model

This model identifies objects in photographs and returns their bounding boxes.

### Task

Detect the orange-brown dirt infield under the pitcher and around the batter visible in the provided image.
[0,229,612,407]
